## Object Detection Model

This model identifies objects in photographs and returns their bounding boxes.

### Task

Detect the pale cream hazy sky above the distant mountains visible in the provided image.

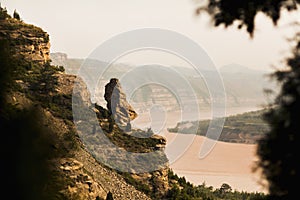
[0,0,300,69]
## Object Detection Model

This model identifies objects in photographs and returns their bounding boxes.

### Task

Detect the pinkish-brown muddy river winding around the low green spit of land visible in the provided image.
[132,106,266,192]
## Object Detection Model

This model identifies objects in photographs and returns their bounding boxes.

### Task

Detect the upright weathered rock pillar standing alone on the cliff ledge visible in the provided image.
[104,78,137,130]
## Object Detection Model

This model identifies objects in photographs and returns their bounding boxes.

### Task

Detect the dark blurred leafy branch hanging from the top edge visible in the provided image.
[196,0,300,37]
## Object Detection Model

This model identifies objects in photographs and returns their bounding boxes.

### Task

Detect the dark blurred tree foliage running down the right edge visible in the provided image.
[257,34,300,198]
